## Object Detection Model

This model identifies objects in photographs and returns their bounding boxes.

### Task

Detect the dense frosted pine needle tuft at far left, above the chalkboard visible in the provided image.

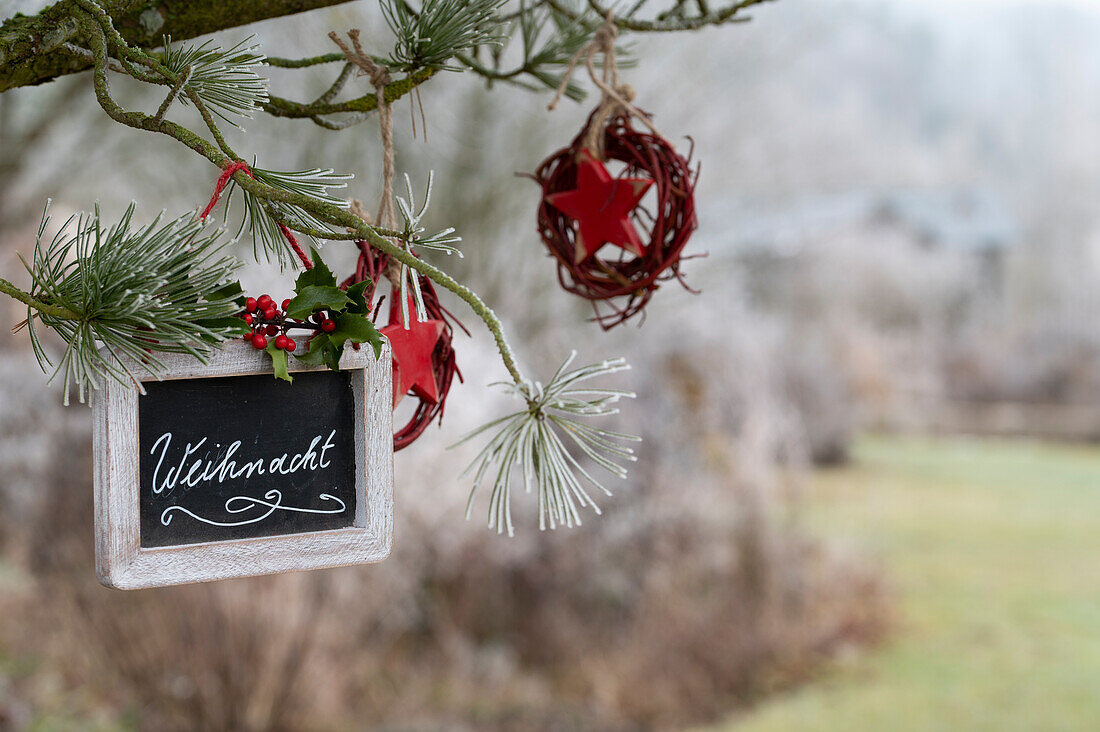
[24,204,243,403]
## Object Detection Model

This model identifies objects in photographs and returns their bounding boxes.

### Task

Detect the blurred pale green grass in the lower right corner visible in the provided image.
[717,438,1100,732]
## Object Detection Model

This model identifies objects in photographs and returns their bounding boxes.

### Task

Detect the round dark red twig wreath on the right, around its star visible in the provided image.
[532,110,699,330]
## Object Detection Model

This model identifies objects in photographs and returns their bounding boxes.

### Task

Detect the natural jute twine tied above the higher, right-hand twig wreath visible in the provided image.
[547,12,664,160]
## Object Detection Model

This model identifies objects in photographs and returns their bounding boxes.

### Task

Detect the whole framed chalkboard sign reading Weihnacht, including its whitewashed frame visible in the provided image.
[94,342,393,589]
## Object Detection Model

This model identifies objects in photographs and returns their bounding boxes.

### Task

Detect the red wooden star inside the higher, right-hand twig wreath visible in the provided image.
[547,151,653,263]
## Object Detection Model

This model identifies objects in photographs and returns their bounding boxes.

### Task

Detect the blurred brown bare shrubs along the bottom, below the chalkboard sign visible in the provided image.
[3,451,884,730]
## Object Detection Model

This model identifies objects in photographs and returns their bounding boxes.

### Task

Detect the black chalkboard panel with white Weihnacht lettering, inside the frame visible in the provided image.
[138,371,355,547]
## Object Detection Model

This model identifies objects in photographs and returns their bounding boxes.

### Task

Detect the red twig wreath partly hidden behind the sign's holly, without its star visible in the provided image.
[341,241,470,451]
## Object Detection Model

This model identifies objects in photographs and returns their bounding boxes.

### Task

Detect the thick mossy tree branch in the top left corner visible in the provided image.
[0,0,349,92]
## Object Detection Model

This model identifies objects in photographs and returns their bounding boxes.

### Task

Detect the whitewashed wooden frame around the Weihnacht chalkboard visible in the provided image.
[92,341,394,590]
